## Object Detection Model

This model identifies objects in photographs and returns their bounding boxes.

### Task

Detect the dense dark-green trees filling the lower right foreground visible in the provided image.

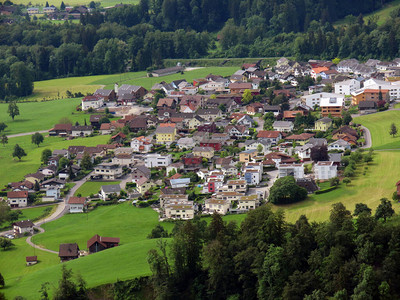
[148,199,400,300]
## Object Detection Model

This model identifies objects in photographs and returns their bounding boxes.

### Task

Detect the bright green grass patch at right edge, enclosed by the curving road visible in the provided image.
[354,110,400,150]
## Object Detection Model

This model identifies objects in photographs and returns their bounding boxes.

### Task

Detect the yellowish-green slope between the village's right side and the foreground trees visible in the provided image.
[274,151,400,222]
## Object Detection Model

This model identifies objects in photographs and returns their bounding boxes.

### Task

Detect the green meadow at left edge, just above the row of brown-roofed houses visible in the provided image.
[0,98,94,135]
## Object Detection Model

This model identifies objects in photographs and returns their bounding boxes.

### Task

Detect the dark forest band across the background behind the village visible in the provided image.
[0,0,400,99]
